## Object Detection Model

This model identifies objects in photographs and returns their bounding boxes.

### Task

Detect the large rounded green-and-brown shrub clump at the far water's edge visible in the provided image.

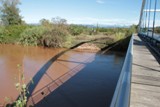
[19,25,68,48]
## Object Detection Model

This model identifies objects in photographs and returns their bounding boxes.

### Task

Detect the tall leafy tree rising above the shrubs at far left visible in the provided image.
[0,0,23,25]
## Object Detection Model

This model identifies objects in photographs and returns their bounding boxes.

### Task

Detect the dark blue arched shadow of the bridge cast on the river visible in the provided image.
[24,36,129,107]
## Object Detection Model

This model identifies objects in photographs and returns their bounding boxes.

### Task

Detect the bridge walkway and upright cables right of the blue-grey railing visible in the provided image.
[130,0,160,107]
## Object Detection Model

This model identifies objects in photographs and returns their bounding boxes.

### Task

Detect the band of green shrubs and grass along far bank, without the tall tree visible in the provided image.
[0,19,136,48]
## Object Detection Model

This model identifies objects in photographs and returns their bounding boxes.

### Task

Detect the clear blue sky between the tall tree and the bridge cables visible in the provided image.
[19,0,142,26]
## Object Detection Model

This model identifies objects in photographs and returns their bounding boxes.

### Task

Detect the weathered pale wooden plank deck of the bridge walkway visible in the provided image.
[130,36,160,107]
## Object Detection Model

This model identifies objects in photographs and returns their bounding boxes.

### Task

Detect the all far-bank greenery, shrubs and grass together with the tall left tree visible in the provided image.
[0,0,136,48]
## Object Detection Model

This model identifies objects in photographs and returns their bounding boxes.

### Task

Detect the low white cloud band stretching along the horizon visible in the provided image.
[67,17,138,26]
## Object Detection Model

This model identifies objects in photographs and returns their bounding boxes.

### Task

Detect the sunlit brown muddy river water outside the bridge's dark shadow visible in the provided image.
[0,44,95,105]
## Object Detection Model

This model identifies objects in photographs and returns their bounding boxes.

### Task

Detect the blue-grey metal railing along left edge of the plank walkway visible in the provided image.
[110,35,134,107]
